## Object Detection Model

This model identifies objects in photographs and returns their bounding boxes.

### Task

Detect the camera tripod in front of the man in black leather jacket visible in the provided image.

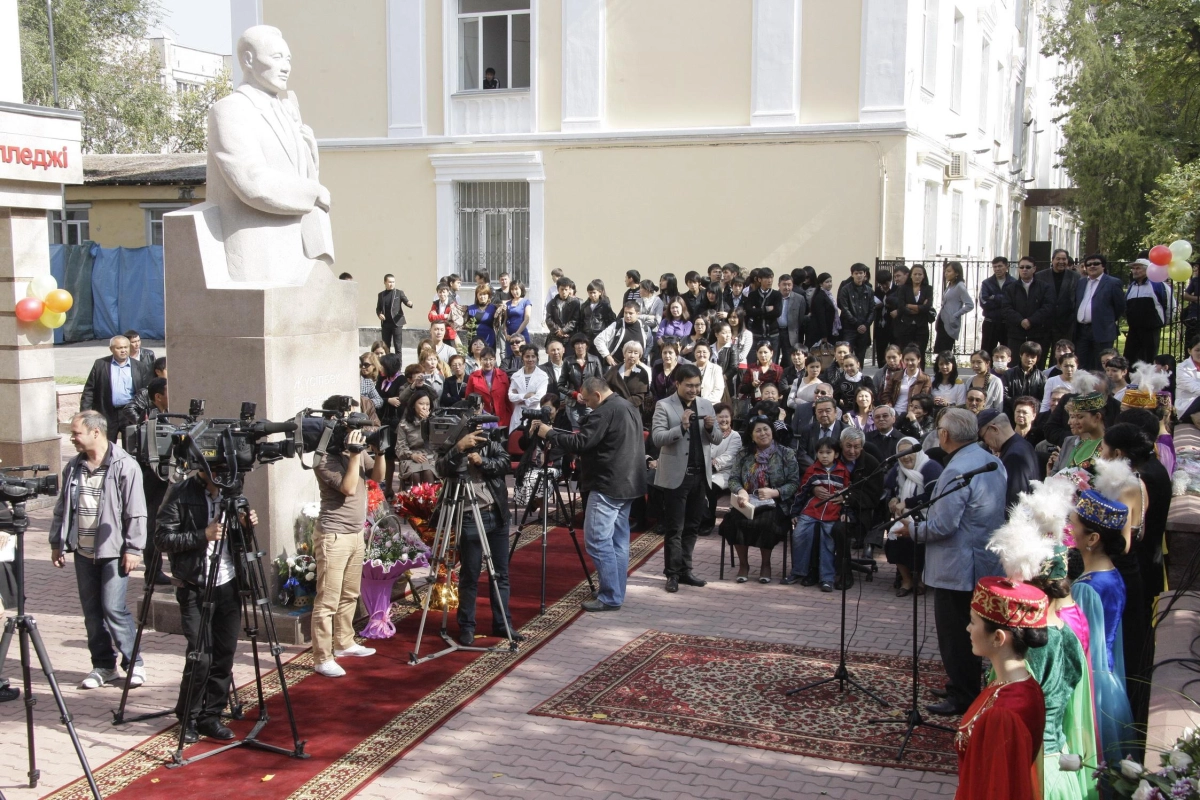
[167,489,308,769]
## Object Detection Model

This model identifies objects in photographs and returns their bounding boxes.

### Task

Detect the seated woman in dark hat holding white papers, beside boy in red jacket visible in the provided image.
[720,416,800,583]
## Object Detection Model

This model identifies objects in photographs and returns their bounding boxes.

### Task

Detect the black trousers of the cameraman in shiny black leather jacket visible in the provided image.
[175,579,241,722]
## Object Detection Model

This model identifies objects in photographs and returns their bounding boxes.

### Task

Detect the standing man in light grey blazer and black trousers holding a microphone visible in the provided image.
[650,363,722,593]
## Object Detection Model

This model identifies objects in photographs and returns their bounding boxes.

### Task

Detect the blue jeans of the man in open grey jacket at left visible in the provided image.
[74,553,142,669]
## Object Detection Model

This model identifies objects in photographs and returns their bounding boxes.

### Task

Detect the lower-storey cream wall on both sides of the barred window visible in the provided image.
[322,137,904,325]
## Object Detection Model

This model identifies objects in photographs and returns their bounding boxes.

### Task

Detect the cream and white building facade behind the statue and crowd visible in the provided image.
[232,0,1075,328]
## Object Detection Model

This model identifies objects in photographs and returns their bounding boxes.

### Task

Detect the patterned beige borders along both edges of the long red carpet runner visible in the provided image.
[43,524,662,800]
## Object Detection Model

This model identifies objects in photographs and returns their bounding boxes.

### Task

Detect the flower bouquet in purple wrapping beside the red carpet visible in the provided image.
[361,506,430,639]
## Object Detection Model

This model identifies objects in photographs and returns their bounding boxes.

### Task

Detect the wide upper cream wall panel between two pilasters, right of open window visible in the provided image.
[606,0,748,130]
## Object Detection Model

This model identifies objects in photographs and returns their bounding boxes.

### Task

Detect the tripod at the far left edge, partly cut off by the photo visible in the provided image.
[0,498,100,800]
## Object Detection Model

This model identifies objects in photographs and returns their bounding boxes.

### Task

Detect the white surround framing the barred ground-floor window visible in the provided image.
[430,153,546,331]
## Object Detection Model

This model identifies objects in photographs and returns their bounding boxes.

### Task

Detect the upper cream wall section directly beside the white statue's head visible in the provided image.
[263,0,388,138]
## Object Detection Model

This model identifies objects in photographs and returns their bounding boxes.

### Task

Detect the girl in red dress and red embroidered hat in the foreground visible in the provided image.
[954,577,1050,800]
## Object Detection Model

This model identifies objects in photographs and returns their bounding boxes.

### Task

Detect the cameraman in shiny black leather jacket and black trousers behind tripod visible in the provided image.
[154,462,258,742]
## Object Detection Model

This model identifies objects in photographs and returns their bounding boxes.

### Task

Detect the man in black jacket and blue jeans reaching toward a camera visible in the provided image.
[532,378,646,612]
